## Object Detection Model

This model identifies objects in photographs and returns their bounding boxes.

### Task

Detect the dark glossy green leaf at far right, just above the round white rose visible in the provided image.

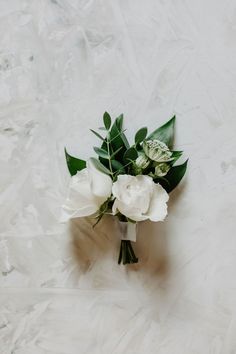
[155,160,188,193]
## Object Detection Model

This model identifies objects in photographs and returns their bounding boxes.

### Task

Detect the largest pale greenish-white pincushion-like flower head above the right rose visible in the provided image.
[143,139,172,162]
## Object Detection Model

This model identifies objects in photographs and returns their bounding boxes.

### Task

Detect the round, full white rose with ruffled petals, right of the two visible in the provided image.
[112,175,169,221]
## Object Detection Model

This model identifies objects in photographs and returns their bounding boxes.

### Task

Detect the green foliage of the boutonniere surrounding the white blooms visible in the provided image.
[65,112,188,196]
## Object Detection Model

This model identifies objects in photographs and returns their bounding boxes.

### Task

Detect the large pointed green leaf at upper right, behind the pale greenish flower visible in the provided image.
[147,116,175,149]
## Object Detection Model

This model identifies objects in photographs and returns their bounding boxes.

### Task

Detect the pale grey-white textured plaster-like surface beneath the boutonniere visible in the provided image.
[0,0,236,354]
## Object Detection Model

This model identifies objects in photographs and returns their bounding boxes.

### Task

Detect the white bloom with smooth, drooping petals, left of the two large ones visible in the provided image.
[61,159,112,222]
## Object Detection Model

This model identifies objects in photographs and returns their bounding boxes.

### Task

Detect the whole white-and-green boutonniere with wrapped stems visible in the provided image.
[63,112,187,264]
